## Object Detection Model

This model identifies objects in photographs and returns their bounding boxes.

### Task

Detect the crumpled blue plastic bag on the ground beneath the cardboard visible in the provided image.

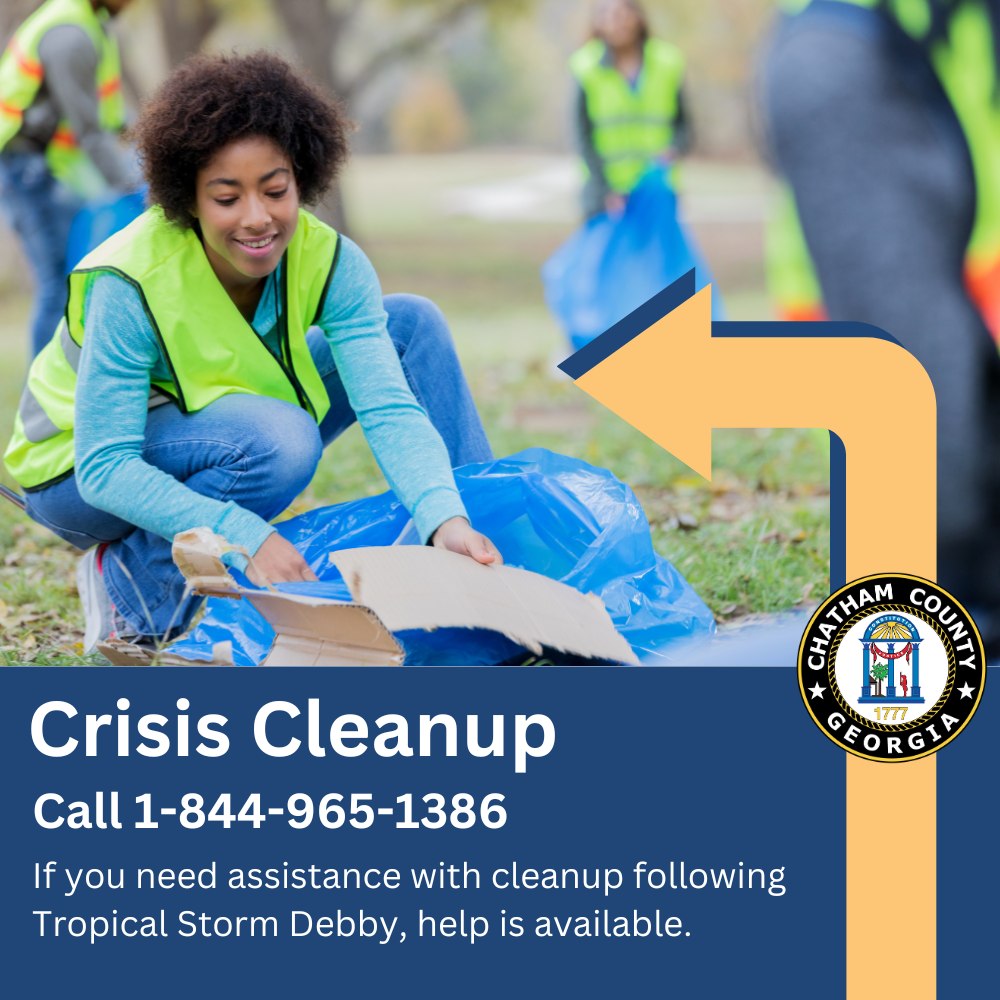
[170,448,715,666]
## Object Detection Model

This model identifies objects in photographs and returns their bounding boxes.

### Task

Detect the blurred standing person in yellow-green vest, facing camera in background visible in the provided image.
[570,0,690,218]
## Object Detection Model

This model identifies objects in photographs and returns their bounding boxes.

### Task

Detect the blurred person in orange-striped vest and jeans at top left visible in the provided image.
[0,0,141,355]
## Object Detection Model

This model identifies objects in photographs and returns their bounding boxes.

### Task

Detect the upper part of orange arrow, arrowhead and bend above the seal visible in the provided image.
[576,288,937,580]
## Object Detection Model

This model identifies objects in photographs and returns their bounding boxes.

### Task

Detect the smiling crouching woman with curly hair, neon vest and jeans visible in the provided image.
[5,53,500,652]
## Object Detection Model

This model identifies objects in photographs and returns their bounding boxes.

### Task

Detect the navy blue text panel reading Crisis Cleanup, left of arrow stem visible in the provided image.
[0,668,844,1000]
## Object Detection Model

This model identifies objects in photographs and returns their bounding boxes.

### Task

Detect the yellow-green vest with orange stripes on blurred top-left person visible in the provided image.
[0,0,125,198]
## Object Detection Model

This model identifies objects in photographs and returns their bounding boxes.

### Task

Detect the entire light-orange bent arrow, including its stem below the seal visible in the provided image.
[564,279,937,1000]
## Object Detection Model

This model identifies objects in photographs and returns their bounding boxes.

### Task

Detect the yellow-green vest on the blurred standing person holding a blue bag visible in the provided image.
[570,38,684,194]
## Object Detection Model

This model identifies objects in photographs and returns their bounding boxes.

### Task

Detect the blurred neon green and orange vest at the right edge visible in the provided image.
[774,0,1000,336]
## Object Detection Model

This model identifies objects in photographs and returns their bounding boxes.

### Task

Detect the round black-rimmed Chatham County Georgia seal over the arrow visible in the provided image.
[798,574,986,762]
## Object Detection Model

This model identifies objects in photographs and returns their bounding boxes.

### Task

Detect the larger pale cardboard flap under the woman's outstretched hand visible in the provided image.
[330,545,637,663]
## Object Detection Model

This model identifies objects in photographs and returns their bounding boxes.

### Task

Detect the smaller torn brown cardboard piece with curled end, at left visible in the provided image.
[171,528,403,667]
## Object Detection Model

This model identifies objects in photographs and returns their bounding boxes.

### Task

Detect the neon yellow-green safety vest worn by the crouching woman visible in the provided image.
[4,206,338,489]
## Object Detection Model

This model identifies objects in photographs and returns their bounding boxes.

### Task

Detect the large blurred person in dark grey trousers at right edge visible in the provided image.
[762,0,1000,656]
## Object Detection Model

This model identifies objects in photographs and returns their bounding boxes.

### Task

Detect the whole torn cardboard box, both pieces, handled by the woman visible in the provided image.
[156,528,636,666]
